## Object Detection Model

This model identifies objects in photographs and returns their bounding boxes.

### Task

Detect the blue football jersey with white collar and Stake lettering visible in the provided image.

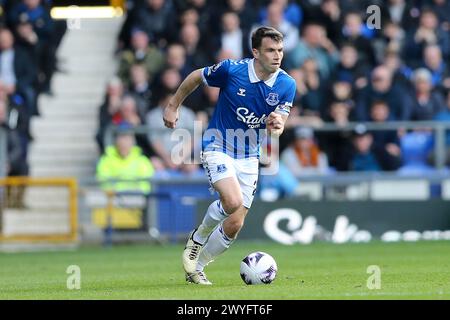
[202,59,296,158]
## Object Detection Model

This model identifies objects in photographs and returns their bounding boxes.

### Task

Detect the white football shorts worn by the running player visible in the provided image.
[201,151,259,209]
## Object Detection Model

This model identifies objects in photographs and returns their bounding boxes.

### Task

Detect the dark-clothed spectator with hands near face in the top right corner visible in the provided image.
[403,8,450,67]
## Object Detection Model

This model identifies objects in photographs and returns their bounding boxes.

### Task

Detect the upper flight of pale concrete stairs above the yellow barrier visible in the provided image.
[29,18,122,179]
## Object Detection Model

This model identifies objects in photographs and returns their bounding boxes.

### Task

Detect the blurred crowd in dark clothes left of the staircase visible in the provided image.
[0,0,66,185]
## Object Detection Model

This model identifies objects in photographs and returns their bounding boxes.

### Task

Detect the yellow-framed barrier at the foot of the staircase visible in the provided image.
[0,177,78,244]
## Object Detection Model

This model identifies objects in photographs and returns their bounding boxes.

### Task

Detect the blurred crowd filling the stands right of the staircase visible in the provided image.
[91,0,450,189]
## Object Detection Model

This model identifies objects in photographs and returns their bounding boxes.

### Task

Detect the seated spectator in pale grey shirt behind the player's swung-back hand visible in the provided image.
[146,91,199,174]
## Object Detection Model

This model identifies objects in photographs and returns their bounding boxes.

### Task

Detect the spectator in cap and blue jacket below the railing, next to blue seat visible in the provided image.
[349,124,382,171]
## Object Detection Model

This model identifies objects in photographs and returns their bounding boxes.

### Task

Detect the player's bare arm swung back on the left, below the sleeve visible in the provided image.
[163,69,203,129]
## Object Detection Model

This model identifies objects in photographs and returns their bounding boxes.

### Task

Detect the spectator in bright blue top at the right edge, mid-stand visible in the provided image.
[423,45,450,93]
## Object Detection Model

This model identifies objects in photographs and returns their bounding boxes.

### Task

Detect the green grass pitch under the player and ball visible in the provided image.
[0,241,450,300]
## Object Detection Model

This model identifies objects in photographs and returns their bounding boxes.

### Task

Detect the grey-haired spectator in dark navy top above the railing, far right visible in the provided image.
[405,68,445,120]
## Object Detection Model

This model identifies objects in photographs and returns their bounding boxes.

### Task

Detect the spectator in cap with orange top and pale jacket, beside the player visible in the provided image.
[281,127,328,177]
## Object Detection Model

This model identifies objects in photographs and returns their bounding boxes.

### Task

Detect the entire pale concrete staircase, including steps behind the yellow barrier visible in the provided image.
[0,18,122,242]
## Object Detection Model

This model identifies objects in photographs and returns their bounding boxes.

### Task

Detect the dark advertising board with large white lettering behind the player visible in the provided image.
[197,199,450,245]
